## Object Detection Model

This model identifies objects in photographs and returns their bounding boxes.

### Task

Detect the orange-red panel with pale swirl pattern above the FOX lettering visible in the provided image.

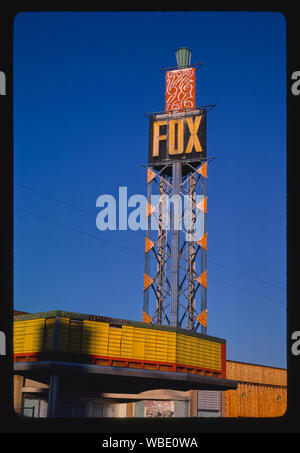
[165,68,195,112]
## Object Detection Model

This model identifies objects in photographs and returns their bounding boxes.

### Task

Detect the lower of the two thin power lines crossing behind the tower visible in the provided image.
[15,207,283,305]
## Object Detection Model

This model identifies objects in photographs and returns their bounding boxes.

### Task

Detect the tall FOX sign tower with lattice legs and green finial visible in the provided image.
[143,47,214,334]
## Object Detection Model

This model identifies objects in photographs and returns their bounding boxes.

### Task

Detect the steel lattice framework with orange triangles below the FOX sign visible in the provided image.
[143,158,213,334]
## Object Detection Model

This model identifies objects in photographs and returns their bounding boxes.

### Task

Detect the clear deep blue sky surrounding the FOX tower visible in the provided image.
[14,12,286,367]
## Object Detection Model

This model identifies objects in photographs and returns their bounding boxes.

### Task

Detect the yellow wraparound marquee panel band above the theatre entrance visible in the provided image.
[14,312,222,371]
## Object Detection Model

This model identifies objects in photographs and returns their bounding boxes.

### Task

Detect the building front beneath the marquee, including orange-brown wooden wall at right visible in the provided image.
[14,360,287,417]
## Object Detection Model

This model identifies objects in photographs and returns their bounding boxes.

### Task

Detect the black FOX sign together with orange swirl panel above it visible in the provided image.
[148,62,206,164]
